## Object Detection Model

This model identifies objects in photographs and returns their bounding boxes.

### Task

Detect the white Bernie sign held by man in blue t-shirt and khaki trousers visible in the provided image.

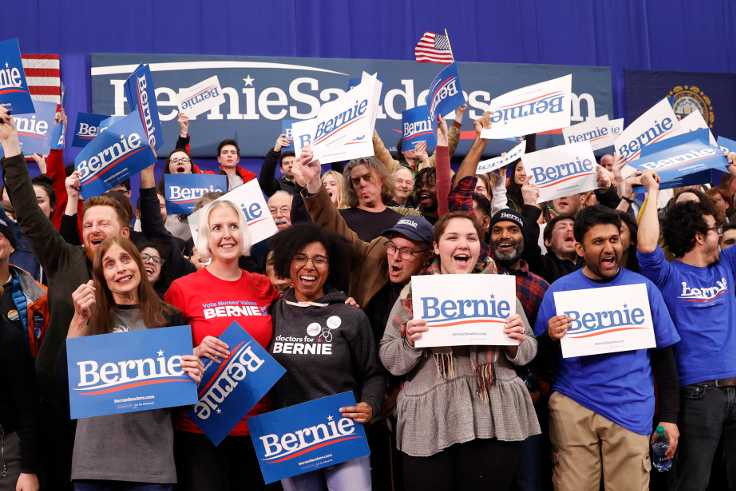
[554,283,656,358]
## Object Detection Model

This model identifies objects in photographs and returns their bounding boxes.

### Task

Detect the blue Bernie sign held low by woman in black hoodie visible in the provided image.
[248,392,370,484]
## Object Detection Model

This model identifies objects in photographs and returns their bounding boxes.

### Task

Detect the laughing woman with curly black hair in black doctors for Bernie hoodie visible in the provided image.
[269,223,385,491]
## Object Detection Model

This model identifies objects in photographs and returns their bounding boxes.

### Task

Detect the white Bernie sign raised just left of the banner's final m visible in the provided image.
[480,74,572,139]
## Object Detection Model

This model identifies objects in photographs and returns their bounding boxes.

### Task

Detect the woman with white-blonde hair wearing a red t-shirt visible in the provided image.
[165,200,279,491]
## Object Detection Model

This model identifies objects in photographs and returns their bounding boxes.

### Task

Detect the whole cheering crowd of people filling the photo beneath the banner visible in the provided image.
[0,97,736,491]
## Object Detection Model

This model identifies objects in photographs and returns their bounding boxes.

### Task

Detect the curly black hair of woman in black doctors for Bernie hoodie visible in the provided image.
[269,223,351,292]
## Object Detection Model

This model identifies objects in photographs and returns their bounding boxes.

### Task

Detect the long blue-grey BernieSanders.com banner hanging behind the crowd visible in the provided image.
[91,53,613,157]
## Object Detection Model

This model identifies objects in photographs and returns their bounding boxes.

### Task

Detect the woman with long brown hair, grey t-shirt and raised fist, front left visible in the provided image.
[66,238,202,491]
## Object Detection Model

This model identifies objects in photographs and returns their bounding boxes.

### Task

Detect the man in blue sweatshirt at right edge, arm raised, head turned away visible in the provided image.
[637,171,736,490]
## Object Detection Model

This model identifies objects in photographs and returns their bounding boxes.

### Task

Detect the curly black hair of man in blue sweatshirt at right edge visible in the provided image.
[662,199,716,257]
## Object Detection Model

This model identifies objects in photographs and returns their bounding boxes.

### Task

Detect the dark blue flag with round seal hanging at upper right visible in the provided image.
[624,70,736,138]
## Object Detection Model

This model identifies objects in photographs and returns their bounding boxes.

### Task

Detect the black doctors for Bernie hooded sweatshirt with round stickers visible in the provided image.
[269,289,385,415]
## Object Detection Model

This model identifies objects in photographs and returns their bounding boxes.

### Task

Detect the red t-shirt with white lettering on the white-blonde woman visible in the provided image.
[164,268,279,436]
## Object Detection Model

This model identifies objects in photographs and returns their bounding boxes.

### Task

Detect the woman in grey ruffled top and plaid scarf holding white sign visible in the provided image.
[380,212,540,491]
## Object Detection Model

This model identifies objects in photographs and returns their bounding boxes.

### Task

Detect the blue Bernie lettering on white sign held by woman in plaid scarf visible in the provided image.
[421,295,511,327]
